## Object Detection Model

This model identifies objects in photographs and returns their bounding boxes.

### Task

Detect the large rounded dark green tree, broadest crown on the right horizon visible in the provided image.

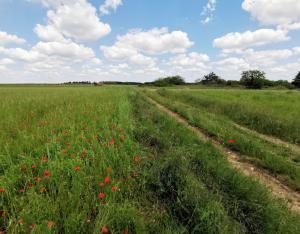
[240,70,266,89]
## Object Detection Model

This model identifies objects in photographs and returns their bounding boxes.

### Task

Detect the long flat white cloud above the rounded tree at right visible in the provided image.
[213,29,290,50]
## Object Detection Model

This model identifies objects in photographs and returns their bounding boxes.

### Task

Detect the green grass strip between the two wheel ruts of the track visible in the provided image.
[147,88,300,191]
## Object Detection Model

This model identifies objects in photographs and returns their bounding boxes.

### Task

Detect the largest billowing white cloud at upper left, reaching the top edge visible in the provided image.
[34,0,111,42]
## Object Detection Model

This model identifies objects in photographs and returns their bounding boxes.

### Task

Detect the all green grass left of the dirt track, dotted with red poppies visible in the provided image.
[0,86,300,234]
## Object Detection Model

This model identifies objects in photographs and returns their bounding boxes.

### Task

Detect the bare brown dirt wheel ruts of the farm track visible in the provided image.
[147,97,300,213]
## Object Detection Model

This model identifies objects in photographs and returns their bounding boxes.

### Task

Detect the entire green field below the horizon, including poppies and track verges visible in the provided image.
[0,86,300,234]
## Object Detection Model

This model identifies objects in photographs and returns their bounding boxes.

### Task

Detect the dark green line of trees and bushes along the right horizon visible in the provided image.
[144,70,300,89]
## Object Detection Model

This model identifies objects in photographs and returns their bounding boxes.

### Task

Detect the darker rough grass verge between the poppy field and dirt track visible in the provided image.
[134,96,300,233]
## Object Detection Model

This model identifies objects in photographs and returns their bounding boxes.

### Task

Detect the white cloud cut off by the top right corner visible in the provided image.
[242,0,300,25]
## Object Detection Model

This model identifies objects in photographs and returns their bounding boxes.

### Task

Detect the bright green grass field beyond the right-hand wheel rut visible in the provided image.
[151,89,300,145]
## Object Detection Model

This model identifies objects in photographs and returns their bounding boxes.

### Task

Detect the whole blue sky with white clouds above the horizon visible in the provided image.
[0,0,300,83]
